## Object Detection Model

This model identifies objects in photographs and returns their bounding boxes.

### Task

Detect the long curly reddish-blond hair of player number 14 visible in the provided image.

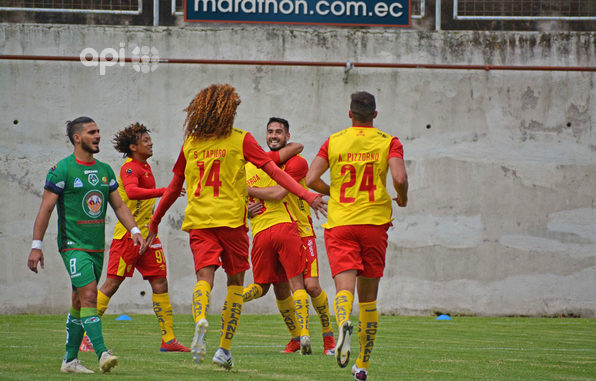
[184,83,241,140]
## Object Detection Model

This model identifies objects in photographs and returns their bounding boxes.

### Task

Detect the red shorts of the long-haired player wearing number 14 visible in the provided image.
[189,226,250,275]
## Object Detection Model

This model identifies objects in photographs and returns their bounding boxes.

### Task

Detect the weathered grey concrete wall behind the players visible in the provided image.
[0,24,596,317]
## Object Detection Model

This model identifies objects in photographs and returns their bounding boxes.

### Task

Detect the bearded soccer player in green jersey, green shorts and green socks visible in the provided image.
[27,117,144,373]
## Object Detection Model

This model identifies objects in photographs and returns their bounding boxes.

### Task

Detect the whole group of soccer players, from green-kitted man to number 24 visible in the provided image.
[27,84,408,380]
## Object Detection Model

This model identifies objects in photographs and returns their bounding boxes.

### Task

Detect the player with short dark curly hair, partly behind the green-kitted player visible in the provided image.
[81,123,190,352]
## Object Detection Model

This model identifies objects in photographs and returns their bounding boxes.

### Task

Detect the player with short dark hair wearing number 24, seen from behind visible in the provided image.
[306,91,408,380]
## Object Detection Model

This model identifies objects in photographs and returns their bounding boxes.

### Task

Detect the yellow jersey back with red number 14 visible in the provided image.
[182,128,248,231]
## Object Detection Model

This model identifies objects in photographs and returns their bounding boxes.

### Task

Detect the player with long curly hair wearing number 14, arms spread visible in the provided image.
[145,84,326,369]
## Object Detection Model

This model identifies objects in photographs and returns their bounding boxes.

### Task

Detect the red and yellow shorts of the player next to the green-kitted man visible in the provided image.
[107,233,168,279]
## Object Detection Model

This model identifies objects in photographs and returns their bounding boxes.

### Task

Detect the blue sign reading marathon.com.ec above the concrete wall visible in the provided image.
[184,0,410,27]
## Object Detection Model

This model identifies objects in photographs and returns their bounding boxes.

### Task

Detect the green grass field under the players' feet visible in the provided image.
[0,315,596,381]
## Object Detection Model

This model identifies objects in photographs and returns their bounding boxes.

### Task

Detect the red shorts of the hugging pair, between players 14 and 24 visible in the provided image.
[250,222,306,284]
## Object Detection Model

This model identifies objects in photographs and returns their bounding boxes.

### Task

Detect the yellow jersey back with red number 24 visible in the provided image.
[323,127,393,229]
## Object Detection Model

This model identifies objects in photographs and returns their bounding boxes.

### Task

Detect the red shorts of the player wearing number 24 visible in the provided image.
[325,224,389,278]
